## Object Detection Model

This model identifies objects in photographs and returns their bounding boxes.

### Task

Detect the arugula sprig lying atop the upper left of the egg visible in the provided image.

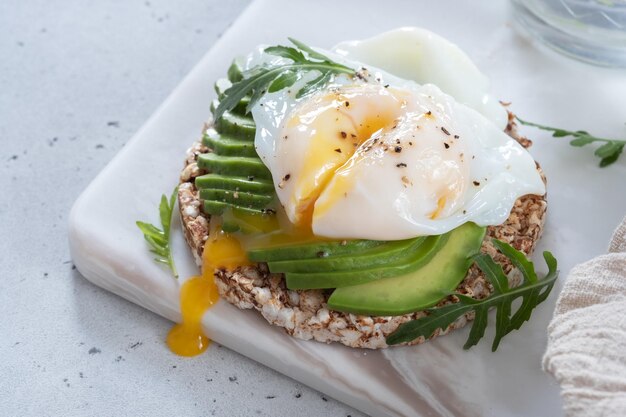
[214,38,355,120]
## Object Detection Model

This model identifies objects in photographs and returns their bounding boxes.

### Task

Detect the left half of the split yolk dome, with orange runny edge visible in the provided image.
[279,85,406,228]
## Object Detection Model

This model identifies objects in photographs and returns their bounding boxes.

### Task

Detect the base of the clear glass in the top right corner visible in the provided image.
[511,0,626,68]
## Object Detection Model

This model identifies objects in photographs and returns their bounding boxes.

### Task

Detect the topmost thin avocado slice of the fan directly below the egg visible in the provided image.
[248,240,385,262]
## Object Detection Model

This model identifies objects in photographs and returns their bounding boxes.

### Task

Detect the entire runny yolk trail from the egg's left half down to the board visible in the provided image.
[167,86,420,356]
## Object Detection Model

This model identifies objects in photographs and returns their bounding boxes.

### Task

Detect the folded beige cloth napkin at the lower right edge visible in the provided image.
[543,218,626,417]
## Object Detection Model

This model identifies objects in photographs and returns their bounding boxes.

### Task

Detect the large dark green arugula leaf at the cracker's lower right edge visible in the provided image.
[387,239,559,351]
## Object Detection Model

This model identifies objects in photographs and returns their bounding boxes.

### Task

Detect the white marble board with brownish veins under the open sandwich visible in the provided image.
[70,0,626,416]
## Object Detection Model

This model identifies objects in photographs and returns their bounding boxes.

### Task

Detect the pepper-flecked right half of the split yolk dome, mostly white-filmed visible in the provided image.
[302,87,469,232]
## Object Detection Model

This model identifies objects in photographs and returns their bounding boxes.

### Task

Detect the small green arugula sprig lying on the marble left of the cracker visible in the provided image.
[136,187,178,278]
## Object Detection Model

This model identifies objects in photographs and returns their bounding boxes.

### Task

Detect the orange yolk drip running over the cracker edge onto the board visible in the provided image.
[167,230,250,356]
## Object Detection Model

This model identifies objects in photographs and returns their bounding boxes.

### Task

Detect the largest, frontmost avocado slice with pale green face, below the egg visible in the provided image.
[328,223,485,316]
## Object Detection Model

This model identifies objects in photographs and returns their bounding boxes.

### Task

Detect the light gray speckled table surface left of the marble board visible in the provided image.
[0,0,362,417]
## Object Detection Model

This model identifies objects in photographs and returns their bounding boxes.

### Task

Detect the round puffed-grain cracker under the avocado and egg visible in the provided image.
[178,112,547,349]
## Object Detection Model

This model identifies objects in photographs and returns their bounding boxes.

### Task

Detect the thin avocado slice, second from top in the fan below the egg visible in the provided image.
[268,237,426,273]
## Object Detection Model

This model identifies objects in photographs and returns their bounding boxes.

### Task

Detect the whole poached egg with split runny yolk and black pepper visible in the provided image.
[246,28,545,240]
